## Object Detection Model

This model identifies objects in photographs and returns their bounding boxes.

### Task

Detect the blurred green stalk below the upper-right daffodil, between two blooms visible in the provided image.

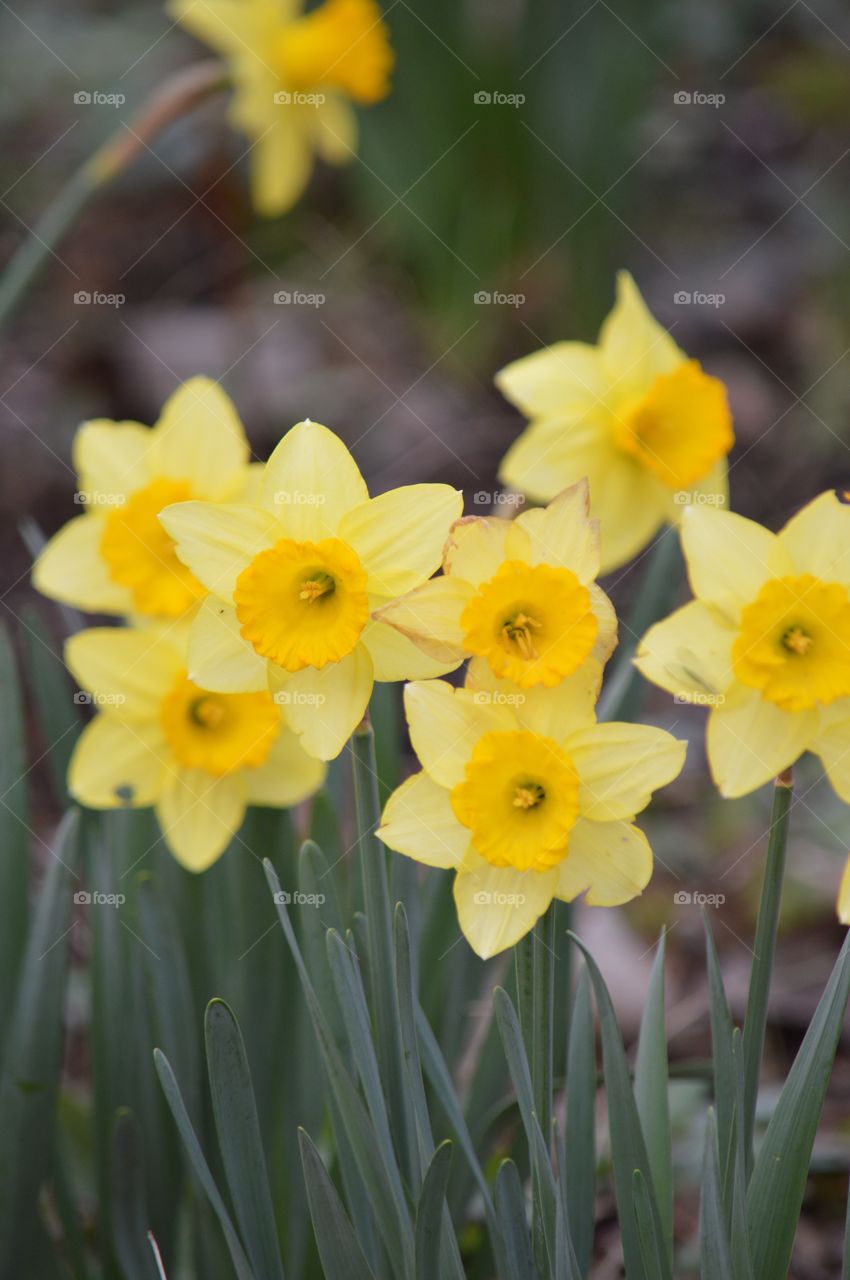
[599,529,682,721]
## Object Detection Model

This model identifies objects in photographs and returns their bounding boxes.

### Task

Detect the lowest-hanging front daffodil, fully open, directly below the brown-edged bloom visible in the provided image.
[378,658,685,959]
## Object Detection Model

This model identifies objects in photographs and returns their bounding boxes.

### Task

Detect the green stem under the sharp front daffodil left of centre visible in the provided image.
[351,719,420,1185]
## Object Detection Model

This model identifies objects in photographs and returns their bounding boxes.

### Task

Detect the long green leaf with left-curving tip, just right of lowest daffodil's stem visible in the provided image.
[571,934,668,1280]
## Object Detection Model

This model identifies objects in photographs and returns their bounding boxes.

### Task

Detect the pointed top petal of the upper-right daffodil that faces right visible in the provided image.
[599,271,685,398]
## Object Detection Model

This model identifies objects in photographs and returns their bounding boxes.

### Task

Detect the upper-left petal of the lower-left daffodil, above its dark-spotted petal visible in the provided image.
[65,627,186,719]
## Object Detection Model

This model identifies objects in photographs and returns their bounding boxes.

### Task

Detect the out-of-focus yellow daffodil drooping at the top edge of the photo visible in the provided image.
[169,0,393,216]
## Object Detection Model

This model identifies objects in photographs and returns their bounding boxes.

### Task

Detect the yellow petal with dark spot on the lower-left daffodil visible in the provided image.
[68,714,169,809]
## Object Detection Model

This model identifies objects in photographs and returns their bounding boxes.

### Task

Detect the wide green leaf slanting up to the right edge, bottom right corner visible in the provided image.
[746,934,850,1280]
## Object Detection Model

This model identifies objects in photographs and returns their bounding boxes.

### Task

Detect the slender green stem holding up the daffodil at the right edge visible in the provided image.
[744,769,792,1175]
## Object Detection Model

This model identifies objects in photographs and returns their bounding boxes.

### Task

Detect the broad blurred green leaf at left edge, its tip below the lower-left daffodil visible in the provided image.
[0,809,79,1275]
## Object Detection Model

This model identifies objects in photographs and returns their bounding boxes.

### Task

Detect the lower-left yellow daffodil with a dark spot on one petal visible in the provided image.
[65,626,325,872]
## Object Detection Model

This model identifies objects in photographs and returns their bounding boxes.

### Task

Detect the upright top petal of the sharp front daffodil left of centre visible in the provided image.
[262,422,369,543]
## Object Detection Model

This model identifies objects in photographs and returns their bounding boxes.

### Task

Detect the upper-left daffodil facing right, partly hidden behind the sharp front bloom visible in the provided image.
[33,378,255,620]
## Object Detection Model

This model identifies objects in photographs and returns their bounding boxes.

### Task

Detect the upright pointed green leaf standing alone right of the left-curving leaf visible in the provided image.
[635,932,673,1265]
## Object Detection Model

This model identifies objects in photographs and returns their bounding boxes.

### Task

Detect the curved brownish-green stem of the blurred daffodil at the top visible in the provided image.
[0,61,228,330]
